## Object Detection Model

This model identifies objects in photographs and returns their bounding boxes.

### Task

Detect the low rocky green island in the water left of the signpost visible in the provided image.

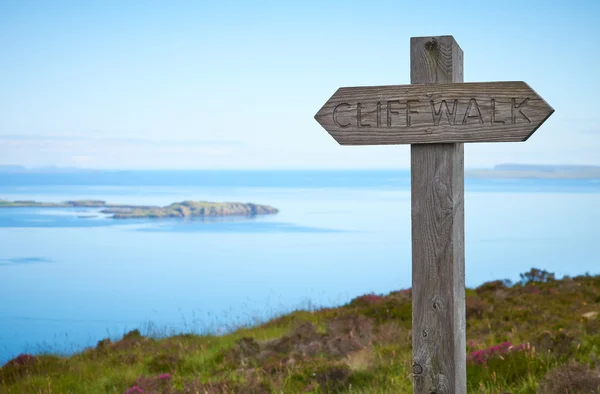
[0,200,279,219]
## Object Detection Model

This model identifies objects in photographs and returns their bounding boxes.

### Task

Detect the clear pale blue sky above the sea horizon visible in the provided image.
[0,0,600,169]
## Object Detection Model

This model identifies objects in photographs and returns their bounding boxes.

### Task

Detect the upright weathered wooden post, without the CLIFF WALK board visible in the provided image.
[410,36,467,394]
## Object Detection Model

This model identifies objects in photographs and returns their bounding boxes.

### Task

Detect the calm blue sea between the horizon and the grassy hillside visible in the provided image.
[0,171,600,362]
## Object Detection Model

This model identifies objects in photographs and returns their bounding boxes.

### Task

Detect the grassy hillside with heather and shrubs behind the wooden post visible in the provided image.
[0,269,600,394]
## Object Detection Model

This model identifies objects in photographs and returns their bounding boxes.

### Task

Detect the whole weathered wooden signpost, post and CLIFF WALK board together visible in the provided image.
[315,36,554,394]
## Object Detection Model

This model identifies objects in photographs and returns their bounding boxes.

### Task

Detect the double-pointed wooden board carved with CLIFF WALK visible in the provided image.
[315,82,554,145]
